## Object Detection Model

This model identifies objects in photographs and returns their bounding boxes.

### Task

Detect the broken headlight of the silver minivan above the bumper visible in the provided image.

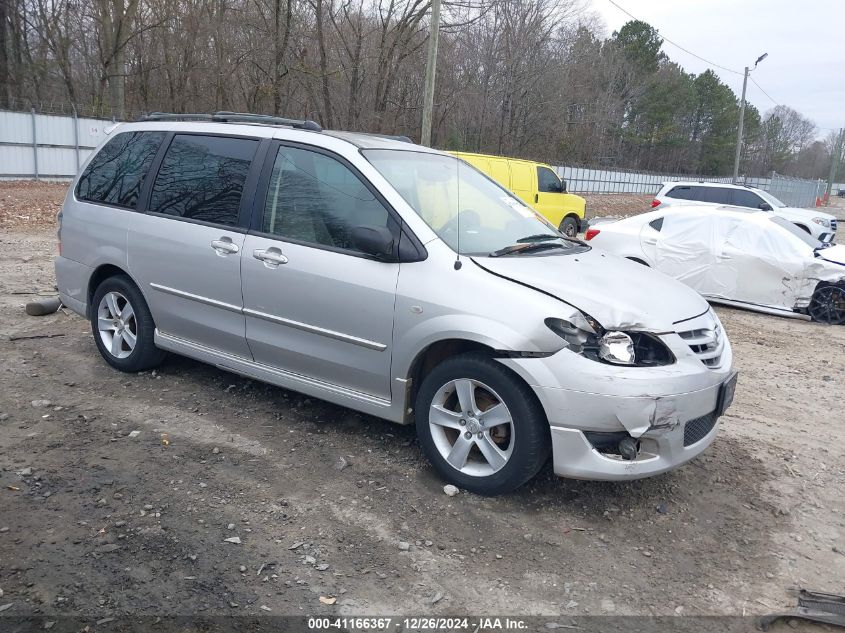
[546,312,675,367]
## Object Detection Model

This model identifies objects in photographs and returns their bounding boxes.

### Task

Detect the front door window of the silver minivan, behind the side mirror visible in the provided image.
[262,146,390,252]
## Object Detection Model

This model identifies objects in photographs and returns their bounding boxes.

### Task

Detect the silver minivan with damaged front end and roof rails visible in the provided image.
[56,113,736,494]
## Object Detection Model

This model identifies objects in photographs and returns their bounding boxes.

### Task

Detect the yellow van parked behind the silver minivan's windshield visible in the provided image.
[449,152,587,237]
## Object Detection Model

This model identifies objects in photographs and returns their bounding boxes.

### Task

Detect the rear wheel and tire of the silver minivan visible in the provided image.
[90,275,165,372]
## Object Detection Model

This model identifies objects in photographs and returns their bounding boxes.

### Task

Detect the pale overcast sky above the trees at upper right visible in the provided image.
[588,0,845,138]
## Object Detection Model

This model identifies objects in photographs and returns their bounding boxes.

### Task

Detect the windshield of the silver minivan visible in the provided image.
[363,149,588,255]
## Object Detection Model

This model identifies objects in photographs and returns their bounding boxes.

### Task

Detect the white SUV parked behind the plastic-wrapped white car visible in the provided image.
[651,182,836,242]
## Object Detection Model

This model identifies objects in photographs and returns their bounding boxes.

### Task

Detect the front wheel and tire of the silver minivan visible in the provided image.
[415,353,551,496]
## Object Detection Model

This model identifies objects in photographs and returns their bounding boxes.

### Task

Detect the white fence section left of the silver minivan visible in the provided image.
[0,110,113,180]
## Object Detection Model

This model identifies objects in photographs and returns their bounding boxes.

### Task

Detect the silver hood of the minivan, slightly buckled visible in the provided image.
[473,248,709,332]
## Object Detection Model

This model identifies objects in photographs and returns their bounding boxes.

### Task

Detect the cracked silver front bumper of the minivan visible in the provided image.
[500,317,735,480]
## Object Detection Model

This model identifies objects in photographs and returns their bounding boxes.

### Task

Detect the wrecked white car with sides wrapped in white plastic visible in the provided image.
[585,205,845,324]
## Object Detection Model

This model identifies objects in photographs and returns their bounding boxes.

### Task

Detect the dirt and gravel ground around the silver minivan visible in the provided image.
[0,183,845,630]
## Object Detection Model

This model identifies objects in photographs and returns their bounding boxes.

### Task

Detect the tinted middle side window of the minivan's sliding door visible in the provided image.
[149,134,258,226]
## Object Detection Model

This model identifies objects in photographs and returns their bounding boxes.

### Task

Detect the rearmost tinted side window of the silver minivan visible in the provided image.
[76,132,165,209]
